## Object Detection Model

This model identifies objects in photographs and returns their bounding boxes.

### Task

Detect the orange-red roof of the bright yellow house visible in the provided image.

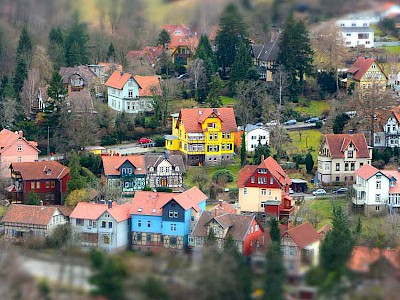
[177,108,237,133]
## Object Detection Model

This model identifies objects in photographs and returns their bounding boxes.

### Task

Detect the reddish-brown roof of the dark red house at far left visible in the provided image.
[10,161,69,180]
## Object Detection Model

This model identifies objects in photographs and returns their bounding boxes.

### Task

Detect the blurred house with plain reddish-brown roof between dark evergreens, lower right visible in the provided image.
[281,222,322,278]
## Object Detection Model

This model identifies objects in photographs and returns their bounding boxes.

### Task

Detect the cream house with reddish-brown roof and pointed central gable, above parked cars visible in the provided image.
[317,133,372,184]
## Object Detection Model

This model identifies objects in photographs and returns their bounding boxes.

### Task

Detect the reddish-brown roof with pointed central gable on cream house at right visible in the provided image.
[324,133,371,158]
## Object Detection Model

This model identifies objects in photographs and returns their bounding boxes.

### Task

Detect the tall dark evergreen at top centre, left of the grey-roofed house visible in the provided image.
[215,4,249,71]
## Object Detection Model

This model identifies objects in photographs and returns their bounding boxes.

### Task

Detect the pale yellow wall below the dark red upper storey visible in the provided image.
[239,187,282,213]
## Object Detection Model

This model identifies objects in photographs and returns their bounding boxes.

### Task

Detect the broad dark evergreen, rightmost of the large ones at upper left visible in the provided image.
[64,15,89,67]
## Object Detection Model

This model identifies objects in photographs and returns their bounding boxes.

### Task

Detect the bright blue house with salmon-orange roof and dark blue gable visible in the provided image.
[131,187,208,251]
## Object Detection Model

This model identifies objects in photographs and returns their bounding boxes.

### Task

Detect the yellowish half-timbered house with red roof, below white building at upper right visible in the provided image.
[347,57,388,91]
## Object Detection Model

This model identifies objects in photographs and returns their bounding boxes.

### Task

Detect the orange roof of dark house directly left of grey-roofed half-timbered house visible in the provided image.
[101,155,146,176]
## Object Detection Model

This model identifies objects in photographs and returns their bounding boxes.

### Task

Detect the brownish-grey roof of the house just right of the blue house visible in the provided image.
[192,211,262,241]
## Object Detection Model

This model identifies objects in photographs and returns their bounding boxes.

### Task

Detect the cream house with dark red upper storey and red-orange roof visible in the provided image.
[238,156,294,221]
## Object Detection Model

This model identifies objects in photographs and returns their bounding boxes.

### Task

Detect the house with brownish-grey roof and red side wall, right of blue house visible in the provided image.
[189,210,265,255]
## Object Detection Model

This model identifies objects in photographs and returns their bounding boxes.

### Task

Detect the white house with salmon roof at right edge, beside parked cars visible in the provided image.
[352,165,400,216]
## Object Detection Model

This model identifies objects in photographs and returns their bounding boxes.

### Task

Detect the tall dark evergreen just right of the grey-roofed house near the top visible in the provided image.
[278,16,314,99]
